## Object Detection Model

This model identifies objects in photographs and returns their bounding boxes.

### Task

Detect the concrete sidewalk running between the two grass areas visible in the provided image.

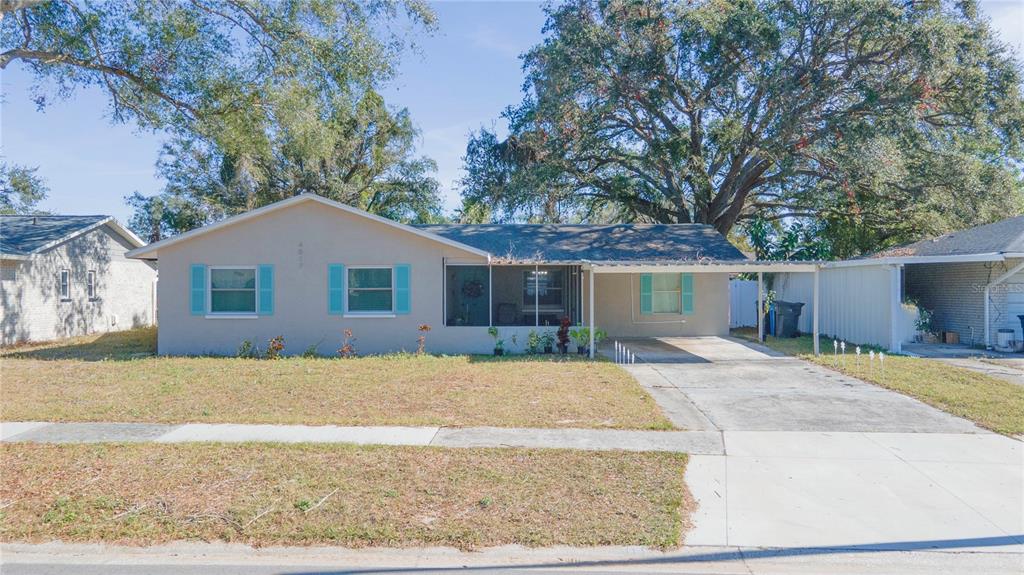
[0,422,724,455]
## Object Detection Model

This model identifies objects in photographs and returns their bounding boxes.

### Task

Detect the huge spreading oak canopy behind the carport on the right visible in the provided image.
[463,0,1024,256]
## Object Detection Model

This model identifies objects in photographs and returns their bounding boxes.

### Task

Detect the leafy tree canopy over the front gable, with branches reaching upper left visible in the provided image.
[0,0,439,237]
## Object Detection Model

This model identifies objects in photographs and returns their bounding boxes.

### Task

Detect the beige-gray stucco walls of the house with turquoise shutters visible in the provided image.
[151,203,728,355]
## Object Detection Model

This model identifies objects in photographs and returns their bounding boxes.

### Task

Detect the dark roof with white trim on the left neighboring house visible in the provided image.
[0,215,142,259]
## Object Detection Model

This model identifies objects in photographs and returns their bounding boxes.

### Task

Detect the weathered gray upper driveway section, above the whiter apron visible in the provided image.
[627,338,982,433]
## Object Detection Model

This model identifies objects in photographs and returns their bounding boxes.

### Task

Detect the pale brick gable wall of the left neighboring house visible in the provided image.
[0,226,157,345]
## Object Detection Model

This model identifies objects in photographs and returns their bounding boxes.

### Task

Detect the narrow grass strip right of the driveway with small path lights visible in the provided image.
[733,329,1024,435]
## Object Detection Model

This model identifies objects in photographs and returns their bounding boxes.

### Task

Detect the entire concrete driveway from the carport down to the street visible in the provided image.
[625,338,1024,552]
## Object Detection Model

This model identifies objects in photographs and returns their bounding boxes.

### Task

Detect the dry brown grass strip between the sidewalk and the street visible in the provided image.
[0,444,692,548]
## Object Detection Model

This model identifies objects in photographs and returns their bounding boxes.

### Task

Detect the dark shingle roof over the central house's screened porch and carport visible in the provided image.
[416,224,746,262]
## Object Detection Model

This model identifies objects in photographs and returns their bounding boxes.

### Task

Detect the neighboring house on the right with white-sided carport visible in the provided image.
[774,216,1024,352]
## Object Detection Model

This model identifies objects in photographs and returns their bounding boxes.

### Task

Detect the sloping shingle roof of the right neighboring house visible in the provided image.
[872,216,1024,258]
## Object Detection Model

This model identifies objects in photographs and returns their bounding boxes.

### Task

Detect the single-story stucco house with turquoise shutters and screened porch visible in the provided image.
[128,194,814,355]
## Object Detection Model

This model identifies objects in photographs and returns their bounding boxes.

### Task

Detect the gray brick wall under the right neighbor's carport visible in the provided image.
[904,260,1024,345]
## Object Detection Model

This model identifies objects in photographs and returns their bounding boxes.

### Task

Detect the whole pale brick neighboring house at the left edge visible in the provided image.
[0,215,157,345]
